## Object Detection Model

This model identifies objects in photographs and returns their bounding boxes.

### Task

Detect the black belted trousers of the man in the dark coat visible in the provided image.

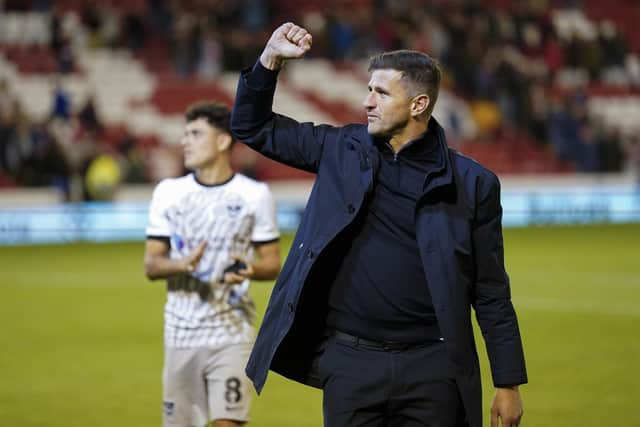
[316,334,467,427]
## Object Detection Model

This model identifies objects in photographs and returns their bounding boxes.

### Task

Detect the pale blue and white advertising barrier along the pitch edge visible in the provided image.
[0,176,640,245]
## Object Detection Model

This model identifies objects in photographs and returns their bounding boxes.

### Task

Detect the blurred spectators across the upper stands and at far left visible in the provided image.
[0,0,640,200]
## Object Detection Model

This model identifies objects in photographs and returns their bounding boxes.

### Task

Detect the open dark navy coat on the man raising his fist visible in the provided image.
[231,71,527,427]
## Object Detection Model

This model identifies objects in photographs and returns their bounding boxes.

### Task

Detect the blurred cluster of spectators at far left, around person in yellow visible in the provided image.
[0,76,148,201]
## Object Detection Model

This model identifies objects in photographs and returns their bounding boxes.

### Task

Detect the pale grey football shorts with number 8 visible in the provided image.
[162,343,252,427]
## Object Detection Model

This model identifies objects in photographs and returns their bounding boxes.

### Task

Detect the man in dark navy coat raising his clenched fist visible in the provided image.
[232,23,527,427]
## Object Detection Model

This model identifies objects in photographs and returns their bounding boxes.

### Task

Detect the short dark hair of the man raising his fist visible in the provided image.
[369,49,442,114]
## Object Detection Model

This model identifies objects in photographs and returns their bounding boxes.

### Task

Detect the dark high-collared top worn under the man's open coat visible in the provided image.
[327,133,443,343]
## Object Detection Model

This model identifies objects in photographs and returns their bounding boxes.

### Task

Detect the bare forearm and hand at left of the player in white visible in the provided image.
[144,238,207,280]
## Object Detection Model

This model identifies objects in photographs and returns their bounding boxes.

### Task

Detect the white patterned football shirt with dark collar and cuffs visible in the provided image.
[146,174,279,348]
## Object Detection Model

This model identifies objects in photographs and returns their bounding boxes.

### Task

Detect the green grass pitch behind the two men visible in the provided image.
[0,224,640,427]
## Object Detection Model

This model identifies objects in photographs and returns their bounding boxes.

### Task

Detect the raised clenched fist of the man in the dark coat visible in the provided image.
[260,22,313,70]
